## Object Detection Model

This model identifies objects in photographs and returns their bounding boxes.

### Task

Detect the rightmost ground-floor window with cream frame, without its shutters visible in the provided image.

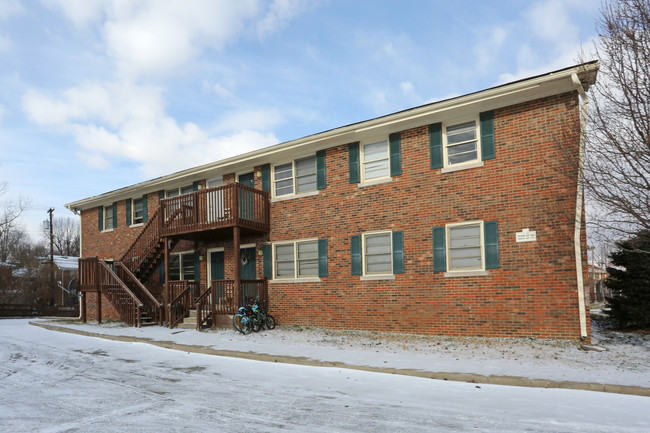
[445,221,485,272]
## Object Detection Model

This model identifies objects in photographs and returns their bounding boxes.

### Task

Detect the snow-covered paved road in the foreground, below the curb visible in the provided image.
[0,320,650,432]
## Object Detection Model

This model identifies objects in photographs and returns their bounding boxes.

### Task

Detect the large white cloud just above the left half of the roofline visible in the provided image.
[23,83,281,176]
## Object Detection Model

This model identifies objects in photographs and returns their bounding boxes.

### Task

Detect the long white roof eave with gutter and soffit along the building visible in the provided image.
[65,62,599,212]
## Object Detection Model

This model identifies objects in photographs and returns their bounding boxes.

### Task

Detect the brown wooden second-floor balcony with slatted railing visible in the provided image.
[159,183,270,238]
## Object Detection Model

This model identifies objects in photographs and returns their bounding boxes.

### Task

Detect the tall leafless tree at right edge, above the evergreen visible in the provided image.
[585,0,650,243]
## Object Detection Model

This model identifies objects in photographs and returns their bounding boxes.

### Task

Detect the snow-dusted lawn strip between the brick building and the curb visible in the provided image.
[36,312,650,387]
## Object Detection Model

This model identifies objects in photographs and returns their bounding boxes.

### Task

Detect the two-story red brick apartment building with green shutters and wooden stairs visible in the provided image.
[66,62,598,339]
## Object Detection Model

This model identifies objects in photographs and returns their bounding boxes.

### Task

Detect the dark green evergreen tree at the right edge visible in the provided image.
[605,230,650,329]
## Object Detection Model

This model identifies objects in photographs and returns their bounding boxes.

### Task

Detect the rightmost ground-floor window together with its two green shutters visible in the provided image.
[433,221,500,274]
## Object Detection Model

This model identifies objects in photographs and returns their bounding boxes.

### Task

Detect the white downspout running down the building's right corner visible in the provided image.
[571,73,589,340]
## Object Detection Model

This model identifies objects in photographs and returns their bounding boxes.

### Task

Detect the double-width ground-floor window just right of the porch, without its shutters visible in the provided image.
[273,239,318,279]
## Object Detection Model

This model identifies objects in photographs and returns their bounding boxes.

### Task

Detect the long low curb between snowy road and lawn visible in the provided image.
[29,322,650,397]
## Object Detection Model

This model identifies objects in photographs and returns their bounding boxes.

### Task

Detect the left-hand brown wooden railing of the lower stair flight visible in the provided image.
[97,260,143,328]
